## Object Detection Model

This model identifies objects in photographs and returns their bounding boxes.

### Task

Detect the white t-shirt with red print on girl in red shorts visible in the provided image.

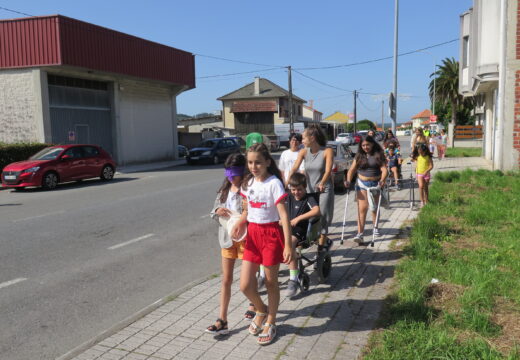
[240,175,287,224]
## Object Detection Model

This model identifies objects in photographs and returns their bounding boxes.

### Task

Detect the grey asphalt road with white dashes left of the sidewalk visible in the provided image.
[0,166,228,360]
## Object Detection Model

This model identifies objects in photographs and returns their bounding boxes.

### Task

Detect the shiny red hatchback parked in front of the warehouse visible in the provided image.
[2,145,116,190]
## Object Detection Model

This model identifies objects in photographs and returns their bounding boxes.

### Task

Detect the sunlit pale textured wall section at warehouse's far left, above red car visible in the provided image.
[0,69,45,143]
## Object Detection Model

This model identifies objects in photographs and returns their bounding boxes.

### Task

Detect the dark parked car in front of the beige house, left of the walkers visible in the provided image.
[186,138,240,165]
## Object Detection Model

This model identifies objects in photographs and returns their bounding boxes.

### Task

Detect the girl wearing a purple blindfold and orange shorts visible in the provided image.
[206,153,255,335]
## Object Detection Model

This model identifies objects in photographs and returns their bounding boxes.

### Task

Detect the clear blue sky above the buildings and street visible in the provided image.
[0,0,472,123]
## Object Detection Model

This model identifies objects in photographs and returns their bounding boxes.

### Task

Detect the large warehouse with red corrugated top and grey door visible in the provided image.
[0,15,195,165]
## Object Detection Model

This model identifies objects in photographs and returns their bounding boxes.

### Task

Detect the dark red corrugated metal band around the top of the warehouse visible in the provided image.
[0,15,195,88]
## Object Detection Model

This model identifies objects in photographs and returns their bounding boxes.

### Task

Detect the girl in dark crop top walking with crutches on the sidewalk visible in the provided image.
[345,136,388,245]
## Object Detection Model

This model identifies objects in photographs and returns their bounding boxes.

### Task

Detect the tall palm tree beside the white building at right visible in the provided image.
[428,58,473,147]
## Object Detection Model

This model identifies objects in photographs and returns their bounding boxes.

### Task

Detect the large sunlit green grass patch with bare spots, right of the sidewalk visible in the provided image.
[364,170,520,360]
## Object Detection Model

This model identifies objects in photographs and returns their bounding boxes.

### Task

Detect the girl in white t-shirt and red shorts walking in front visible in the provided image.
[231,144,295,345]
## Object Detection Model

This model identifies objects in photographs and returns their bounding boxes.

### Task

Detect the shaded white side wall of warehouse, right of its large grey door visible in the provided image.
[116,80,175,164]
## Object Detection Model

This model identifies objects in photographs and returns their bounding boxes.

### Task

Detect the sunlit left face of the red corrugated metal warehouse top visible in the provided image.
[0,17,61,68]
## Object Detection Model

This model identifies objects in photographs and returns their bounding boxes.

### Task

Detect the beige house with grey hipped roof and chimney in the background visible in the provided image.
[217,77,306,135]
